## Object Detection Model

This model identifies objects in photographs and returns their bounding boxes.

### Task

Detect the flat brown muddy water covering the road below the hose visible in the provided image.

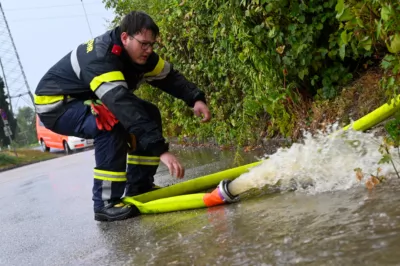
[111,182,400,265]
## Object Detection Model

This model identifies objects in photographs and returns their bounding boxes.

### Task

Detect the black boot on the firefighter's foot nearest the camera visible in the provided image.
[94,201,140,222]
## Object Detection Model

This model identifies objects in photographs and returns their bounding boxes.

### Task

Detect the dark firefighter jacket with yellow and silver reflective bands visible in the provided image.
[35,27,205,155]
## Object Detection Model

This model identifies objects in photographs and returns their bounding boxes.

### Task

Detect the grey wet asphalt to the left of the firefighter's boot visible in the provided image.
[0,151,103,265]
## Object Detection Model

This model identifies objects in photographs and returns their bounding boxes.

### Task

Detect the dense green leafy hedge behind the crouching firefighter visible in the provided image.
[103,0,400,145]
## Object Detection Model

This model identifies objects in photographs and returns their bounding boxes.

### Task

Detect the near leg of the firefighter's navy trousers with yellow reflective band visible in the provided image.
[52,100,128,210]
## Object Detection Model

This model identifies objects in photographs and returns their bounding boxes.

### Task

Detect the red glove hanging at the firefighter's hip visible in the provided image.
[85,100,118,131]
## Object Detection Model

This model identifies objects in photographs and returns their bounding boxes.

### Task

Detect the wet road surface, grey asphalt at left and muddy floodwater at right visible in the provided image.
[0,128,400,265]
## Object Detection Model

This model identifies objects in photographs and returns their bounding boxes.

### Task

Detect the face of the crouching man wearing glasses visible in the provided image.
[121,29,155,65]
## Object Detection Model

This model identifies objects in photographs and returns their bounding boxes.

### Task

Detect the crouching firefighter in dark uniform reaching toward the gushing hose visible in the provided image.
[34,11,211,221]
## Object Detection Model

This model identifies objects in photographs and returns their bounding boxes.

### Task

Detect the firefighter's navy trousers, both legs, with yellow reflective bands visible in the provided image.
[51,100,162,211]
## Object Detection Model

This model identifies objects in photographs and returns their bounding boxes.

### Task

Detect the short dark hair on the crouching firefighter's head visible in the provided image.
[119,11,160,37]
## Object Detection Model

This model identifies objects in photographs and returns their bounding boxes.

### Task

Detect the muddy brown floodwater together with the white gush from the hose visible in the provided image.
[91,128,400,265]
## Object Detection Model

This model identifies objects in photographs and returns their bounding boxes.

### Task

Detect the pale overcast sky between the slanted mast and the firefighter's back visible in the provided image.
[0,0,113,109]
